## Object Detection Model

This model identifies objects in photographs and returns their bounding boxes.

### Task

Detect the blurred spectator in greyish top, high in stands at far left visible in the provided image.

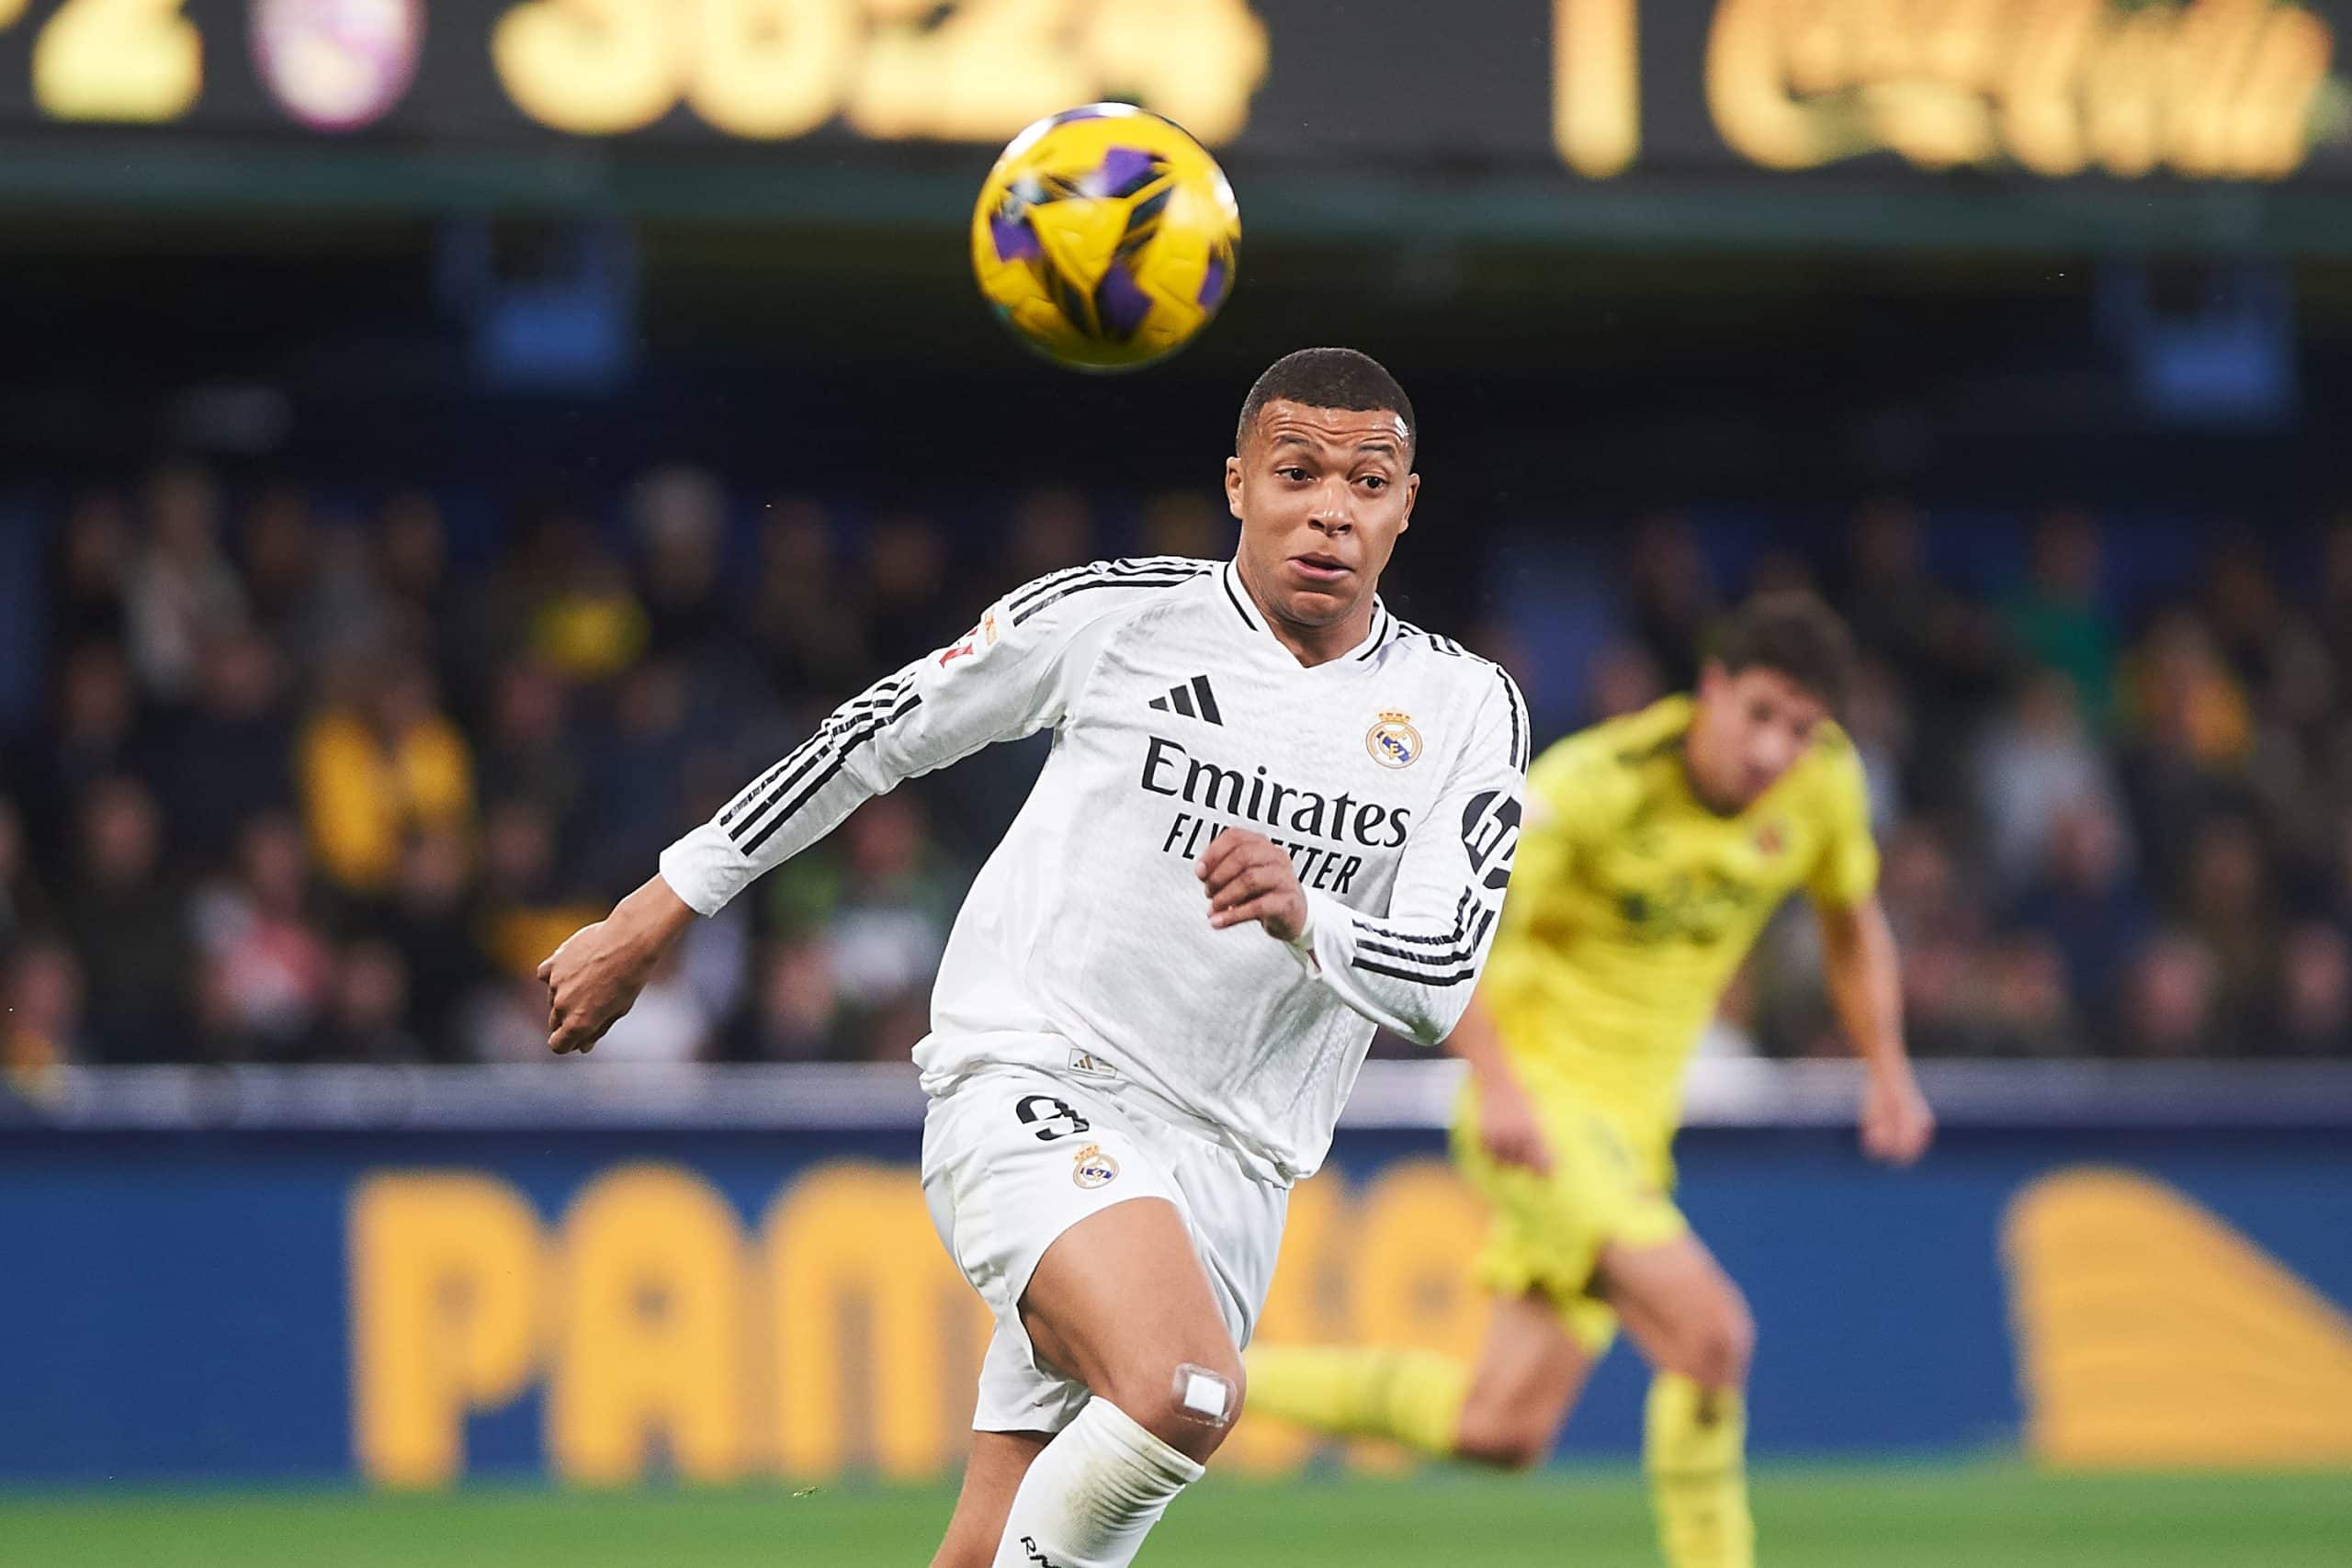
[125,466,244,703]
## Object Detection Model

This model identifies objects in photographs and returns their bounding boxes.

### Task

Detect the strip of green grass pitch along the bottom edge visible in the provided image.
[0,1464,2352,1568]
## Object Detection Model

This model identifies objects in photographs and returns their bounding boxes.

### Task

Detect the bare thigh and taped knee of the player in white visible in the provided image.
[1021,1197,1242,1458]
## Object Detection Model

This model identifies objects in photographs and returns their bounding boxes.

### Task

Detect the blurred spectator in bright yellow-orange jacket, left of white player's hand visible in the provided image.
[301,656,473,896]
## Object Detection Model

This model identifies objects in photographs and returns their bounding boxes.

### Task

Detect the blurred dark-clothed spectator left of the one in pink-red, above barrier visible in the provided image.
[66,776,190,1063]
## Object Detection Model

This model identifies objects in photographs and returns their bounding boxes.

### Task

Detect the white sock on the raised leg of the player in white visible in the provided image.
[995,1399,1200,1568]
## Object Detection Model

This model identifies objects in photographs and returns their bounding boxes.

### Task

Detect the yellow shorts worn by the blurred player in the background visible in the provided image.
[1453,1086,1691,1357]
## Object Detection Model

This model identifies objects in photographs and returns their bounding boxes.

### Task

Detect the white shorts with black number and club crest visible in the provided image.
[922,1067,1291,1432]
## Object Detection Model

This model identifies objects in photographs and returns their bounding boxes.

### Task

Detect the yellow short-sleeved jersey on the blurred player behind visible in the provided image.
[1482,696,1879,1166]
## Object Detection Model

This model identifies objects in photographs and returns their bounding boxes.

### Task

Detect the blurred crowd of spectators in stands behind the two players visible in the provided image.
[0,468,2352,1069]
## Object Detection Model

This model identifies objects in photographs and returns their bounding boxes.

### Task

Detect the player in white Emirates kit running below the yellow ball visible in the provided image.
[541,348,1529,1568]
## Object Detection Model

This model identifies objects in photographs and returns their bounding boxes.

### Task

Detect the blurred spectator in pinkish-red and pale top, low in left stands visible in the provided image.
[195,811,334,1058]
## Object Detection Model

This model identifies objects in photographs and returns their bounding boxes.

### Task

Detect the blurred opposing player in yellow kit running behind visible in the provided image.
[1249,592,1936,1568]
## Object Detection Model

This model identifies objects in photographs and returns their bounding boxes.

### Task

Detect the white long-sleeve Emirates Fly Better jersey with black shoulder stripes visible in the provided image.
[661,558,1529,1182]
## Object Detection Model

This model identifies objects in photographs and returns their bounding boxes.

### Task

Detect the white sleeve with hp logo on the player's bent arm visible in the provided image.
[1303,670,1529,1046]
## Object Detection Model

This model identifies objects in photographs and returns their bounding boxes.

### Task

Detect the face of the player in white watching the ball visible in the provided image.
[1226,400,1420,627]
